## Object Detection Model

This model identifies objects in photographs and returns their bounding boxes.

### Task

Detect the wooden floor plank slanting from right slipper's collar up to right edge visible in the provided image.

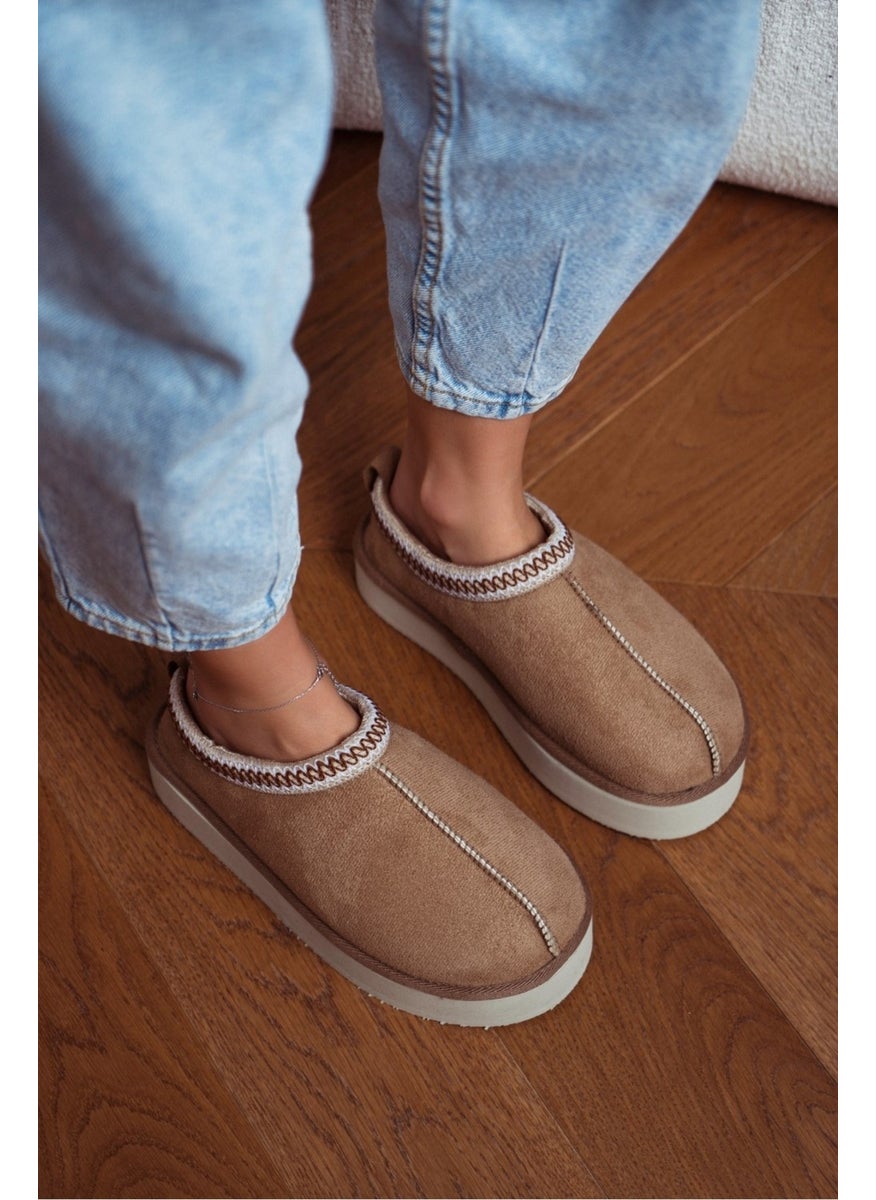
[528,242,836,583]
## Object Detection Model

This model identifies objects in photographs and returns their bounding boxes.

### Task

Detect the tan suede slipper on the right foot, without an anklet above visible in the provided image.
[354,448,748,838]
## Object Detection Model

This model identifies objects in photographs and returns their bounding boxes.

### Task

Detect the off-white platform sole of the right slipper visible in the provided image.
[355,560,745,840]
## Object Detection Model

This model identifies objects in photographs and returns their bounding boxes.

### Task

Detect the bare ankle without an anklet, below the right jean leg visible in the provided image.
[389,395,545,565]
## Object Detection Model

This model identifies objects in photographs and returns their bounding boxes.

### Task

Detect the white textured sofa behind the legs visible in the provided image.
[328,0,836,204]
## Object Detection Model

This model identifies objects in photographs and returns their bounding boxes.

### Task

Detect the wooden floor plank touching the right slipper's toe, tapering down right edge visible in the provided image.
[659,586,838,1074]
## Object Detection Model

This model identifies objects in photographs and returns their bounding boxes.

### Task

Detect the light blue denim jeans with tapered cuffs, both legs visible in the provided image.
[40,0,760,650]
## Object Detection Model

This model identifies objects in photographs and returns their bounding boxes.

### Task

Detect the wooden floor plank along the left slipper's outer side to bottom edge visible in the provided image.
[41,559,602,1196]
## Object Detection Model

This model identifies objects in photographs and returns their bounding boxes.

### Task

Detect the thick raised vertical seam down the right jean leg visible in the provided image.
[410,0,454,389]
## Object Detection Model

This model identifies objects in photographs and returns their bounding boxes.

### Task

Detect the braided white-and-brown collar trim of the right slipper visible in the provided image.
[371,476,575,600]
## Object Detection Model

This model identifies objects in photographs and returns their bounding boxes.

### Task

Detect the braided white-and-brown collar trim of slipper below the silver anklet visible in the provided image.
[168,667,390,796]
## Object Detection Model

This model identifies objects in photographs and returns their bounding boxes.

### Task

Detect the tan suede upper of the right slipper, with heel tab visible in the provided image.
[361,454,745,803]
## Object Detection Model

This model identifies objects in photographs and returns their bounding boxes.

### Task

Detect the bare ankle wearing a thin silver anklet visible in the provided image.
[186,610,360,762]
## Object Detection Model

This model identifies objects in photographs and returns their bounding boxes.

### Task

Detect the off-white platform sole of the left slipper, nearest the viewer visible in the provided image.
[149,761,593,1028]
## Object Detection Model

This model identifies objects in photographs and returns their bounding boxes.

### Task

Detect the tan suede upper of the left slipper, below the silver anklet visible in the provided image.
[150,681,589,988]
